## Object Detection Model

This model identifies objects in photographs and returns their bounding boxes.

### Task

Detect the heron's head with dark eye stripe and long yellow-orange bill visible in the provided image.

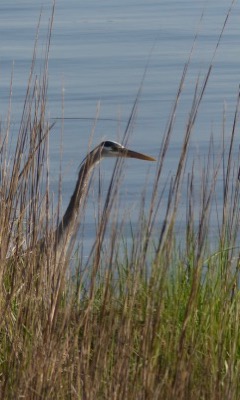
[100,140,156,161]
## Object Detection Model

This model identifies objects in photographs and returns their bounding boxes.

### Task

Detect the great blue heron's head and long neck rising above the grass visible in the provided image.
[51,140,156,253]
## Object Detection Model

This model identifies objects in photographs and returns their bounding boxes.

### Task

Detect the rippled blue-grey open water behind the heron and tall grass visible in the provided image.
[0,0,240,253]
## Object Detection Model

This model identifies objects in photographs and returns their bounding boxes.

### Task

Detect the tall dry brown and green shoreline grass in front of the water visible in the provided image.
[0,3,240,400]
